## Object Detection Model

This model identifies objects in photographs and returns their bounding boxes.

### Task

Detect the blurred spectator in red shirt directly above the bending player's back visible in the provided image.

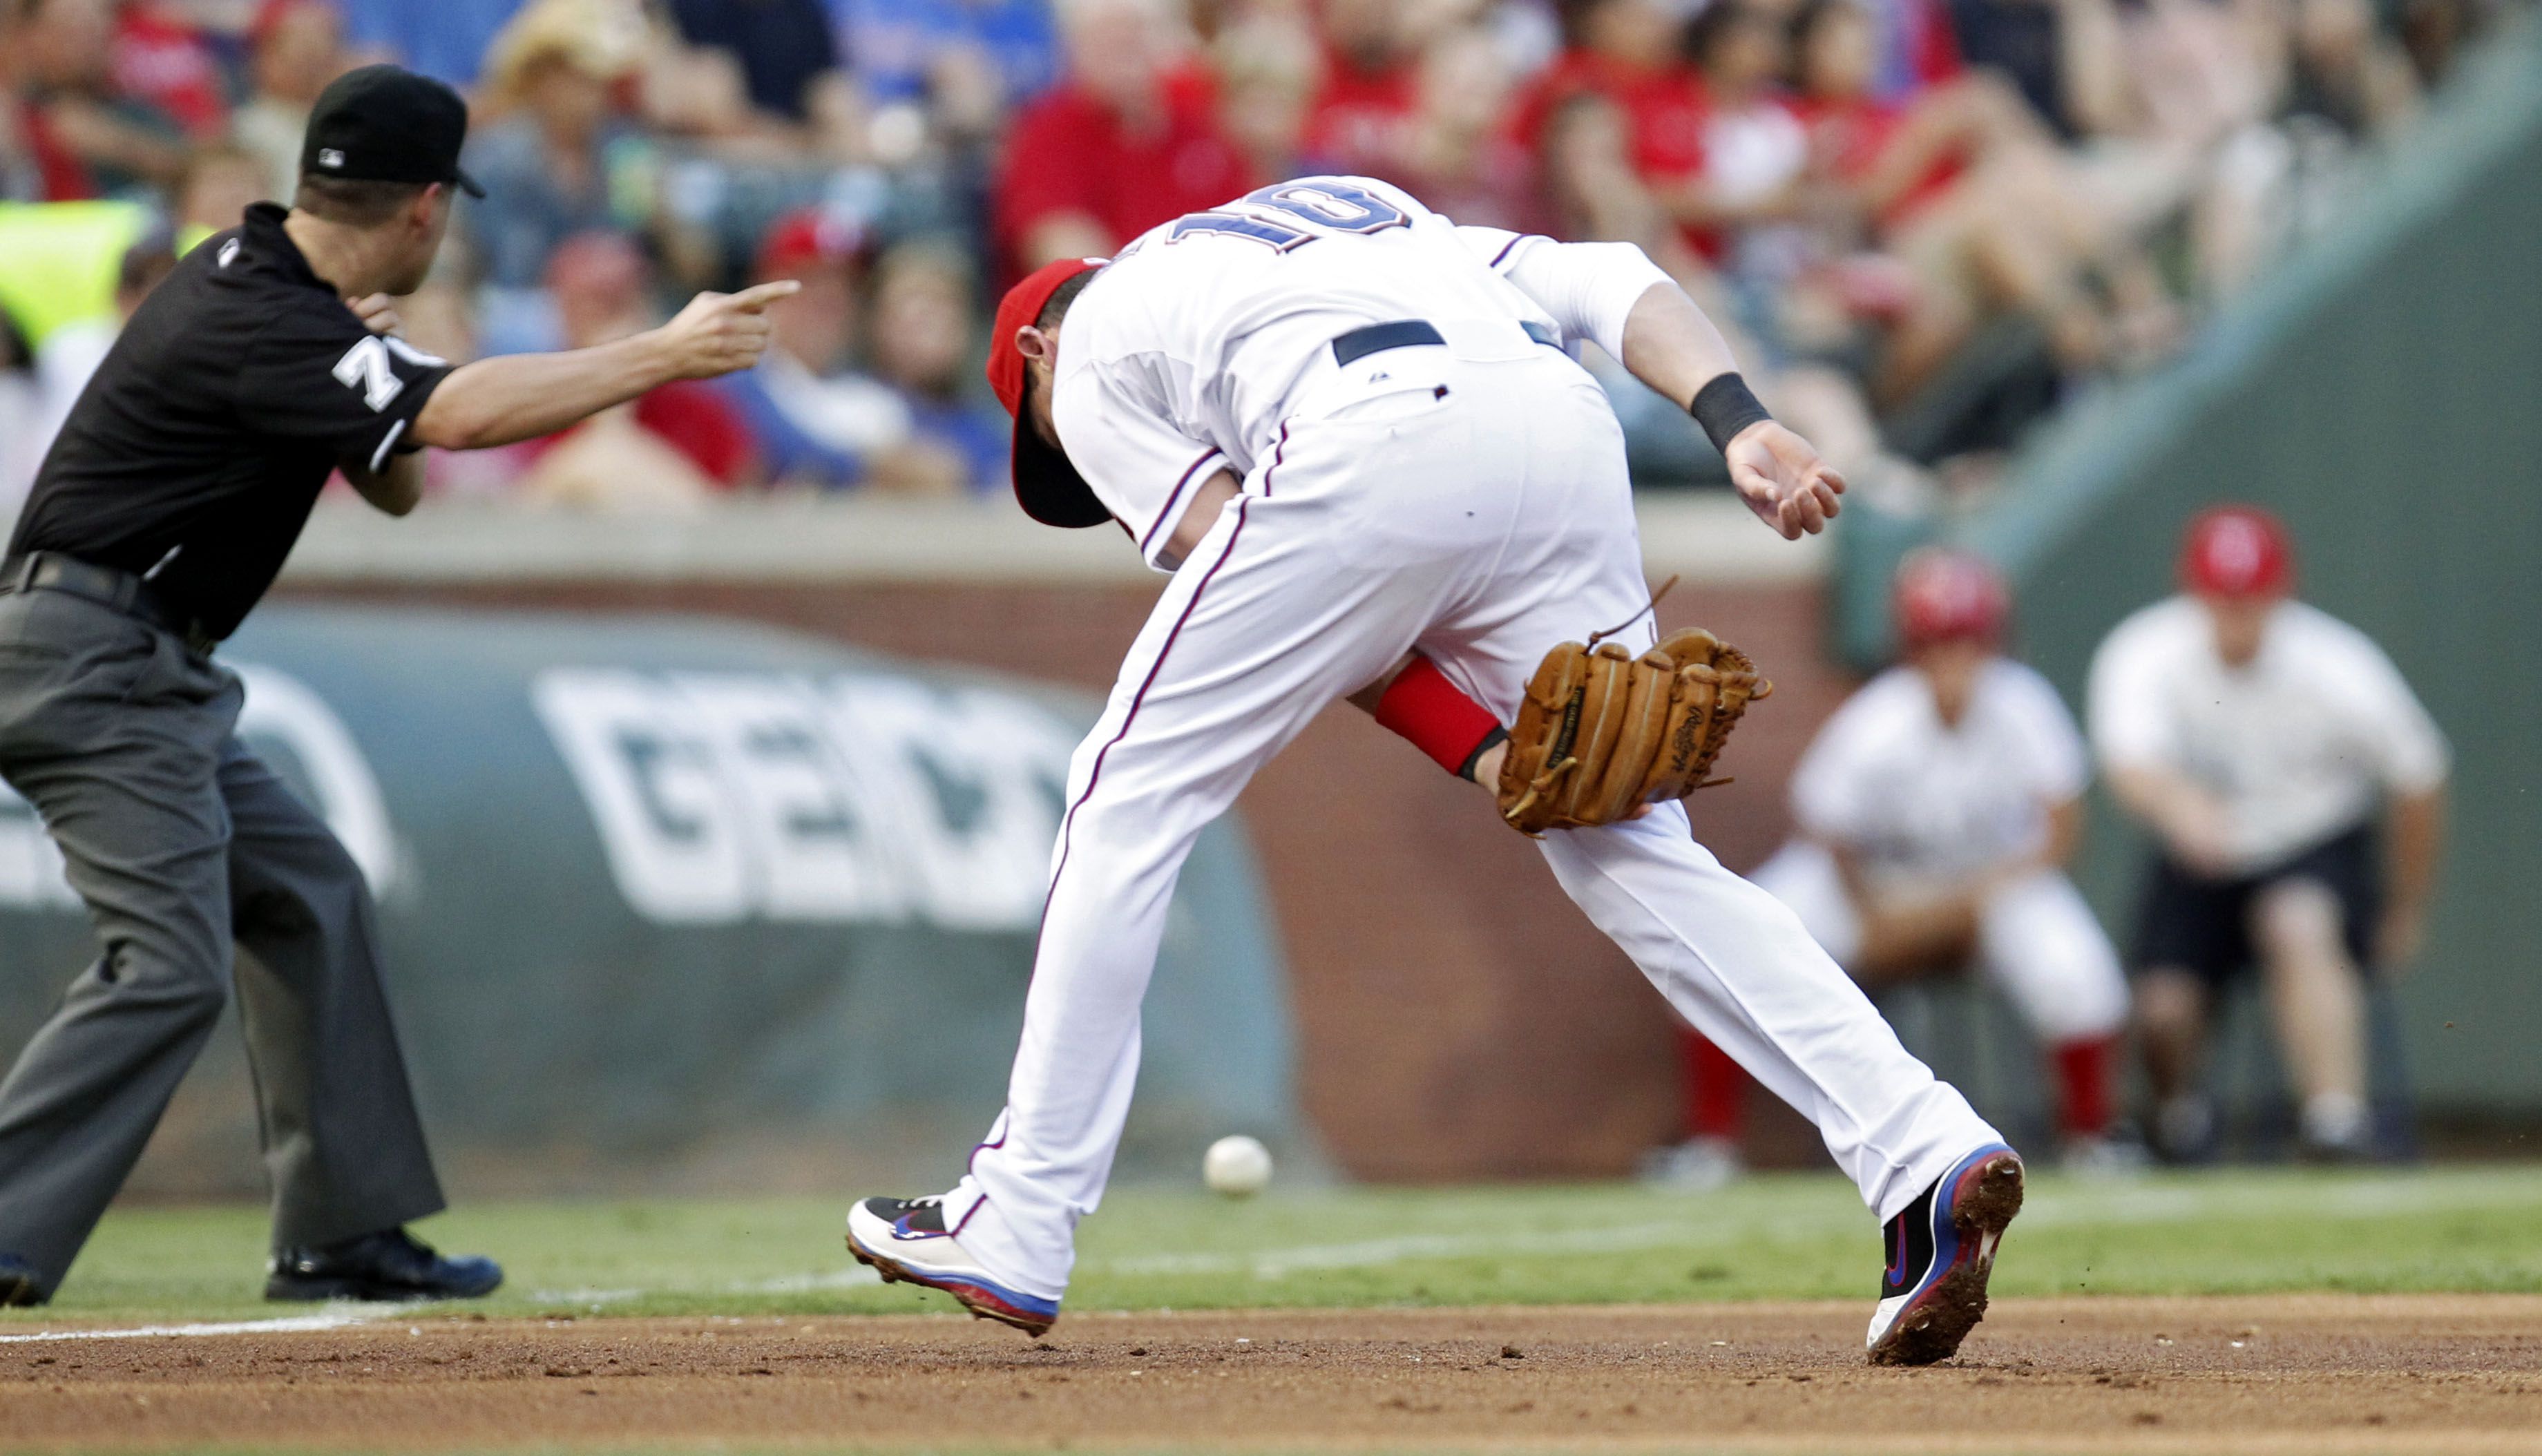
[997,0,1259,272]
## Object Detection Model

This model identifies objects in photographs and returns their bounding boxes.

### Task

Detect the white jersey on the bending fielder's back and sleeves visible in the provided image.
[1050,178,1667,564]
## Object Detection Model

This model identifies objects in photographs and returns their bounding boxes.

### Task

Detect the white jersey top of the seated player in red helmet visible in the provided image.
[1792,658,2090,887]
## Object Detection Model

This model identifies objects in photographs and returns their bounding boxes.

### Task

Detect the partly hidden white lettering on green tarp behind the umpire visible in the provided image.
[0,663,399,910]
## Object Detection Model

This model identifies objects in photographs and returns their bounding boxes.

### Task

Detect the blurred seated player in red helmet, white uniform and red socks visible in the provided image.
[1650,546,2128,1187]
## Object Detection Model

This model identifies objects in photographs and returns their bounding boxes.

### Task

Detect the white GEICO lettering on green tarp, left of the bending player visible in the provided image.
[531,669,1078,930]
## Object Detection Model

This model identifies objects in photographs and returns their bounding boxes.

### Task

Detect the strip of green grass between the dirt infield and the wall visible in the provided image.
[0,1167,2542,1332]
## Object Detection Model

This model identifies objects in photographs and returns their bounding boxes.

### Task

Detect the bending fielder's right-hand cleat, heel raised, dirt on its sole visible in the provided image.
[1863,1143,2021,1365]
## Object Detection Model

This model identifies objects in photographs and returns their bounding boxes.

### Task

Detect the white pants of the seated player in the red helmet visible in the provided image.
[1754,841,2128,1047]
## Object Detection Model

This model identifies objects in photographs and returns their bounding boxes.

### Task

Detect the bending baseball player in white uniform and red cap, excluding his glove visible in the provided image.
[849,178,2021,1362]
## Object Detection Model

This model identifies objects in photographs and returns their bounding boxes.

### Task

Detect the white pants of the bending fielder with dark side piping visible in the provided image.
[946,338,2000,1299]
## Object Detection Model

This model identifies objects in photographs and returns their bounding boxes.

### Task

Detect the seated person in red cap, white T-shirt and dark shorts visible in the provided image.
[2090,506,2448,1159]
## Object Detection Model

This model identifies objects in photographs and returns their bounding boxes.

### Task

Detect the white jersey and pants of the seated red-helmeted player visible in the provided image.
[1754,658,2128,1042]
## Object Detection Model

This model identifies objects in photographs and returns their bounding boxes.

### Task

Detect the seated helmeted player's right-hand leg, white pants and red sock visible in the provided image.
[1978,869,2128,1167]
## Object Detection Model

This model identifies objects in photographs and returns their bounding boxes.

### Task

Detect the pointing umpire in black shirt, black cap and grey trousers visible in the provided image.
[0,66,793,1303]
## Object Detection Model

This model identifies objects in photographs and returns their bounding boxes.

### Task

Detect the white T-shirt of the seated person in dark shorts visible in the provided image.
[2090,597,2448,872]
